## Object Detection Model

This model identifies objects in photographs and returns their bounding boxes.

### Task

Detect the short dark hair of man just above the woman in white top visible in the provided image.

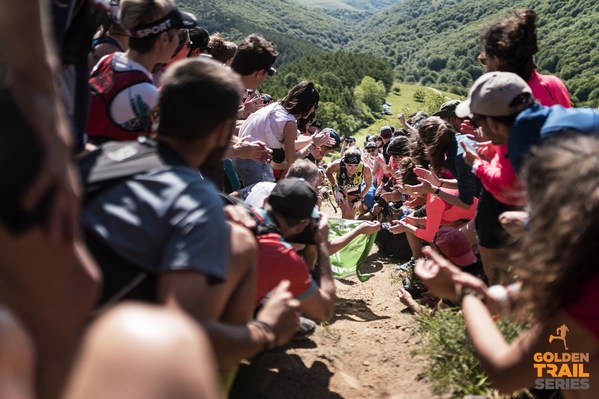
[231,34,279,75]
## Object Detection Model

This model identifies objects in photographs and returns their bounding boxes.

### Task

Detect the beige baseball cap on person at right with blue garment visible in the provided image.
[455,72,532,118]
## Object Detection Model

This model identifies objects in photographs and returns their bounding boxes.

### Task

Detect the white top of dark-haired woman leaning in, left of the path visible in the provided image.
[239,102,296,149]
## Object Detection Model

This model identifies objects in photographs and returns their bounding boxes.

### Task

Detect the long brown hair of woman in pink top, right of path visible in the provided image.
[418,116,455,173]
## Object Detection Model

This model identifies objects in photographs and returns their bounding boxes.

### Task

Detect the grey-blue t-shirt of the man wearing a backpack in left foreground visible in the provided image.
[83,166,230,280]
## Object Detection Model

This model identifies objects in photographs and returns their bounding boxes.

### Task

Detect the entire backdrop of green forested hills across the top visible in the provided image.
[179,0,599,107]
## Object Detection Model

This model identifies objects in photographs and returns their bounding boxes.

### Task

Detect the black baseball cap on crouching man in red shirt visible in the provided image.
[268,177,319,219]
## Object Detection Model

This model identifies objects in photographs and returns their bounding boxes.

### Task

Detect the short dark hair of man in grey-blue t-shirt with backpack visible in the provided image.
[158,57,243,140]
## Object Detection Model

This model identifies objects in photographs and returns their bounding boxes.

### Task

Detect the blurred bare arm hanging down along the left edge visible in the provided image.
[0,0,80,241]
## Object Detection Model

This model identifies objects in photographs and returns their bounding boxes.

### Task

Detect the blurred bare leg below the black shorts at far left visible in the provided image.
[0,226,100,399]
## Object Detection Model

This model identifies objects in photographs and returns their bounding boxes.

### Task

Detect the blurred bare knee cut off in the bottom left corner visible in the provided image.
[0,307,35,399]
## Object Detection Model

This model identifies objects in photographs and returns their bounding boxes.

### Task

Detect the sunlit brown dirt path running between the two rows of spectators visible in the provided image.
[231,245,436,399]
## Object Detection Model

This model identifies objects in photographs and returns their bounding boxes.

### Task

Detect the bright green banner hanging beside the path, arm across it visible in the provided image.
[329,218,376,282]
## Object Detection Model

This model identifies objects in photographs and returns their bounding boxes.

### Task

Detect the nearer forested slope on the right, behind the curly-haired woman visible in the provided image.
[351,0,599,107]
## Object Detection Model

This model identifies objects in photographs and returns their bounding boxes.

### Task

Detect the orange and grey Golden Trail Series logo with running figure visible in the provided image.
[533,324,591,390]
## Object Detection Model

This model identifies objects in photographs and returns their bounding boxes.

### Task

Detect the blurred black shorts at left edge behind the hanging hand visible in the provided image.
[0,89,51,234]
